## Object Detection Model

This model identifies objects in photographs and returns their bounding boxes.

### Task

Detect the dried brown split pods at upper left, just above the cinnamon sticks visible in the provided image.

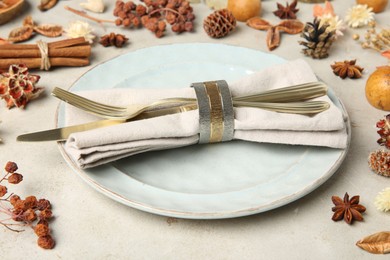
[8,16,62,42]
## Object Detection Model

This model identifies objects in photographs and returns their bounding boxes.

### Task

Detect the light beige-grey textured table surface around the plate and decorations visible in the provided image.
[0,0,390,259]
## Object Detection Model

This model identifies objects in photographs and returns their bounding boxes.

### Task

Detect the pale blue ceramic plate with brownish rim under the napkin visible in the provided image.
[58,43,350,219]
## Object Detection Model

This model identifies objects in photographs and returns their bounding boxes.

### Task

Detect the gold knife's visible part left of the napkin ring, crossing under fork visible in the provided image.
[16,104,198,142]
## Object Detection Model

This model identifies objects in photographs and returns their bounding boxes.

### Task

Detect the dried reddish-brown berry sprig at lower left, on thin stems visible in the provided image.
[0,162,55,249]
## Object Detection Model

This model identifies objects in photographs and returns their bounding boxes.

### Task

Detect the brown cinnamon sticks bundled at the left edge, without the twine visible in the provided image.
[0,37,91,71]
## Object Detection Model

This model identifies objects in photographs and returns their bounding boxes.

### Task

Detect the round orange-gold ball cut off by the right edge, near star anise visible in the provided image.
[366,66,390,111]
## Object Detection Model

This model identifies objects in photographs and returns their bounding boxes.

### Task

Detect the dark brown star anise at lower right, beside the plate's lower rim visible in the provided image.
[332,192,366,224]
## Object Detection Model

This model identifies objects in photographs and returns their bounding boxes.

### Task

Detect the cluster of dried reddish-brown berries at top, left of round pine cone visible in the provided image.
[113,0,195,37]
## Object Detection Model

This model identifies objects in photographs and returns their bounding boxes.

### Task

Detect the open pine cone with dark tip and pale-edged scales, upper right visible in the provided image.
[299,19,335,59]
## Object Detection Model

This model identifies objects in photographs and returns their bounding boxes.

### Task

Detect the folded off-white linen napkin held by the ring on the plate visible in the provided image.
[65,60,348,168]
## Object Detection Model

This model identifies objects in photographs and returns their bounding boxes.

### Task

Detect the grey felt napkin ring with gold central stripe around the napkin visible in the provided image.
[191,80,234,143]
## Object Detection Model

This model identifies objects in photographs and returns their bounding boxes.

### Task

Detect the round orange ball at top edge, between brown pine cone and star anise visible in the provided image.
[227,0,261,22]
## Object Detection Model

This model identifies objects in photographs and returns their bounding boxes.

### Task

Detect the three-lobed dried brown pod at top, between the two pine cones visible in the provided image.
[246,17,304,51]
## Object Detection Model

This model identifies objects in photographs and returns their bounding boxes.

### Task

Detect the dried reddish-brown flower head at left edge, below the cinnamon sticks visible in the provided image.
[0,64,44,108]
